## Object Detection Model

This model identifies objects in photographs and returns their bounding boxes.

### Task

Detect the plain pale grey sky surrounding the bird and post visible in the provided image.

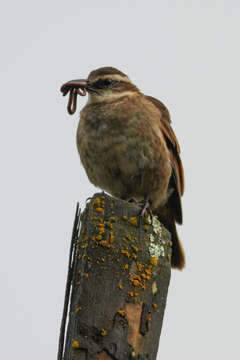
[0,0,240,360]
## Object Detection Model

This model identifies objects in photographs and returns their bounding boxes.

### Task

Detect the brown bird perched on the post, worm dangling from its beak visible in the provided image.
[61,67,185,269]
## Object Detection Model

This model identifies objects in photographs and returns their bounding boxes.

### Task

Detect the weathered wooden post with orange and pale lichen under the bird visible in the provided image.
[58,193,171,360]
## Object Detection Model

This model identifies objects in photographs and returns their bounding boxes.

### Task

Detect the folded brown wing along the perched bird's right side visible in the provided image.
[146,96,184,224]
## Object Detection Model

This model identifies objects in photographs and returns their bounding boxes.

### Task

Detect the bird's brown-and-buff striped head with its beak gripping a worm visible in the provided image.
[61,67,139,112]
